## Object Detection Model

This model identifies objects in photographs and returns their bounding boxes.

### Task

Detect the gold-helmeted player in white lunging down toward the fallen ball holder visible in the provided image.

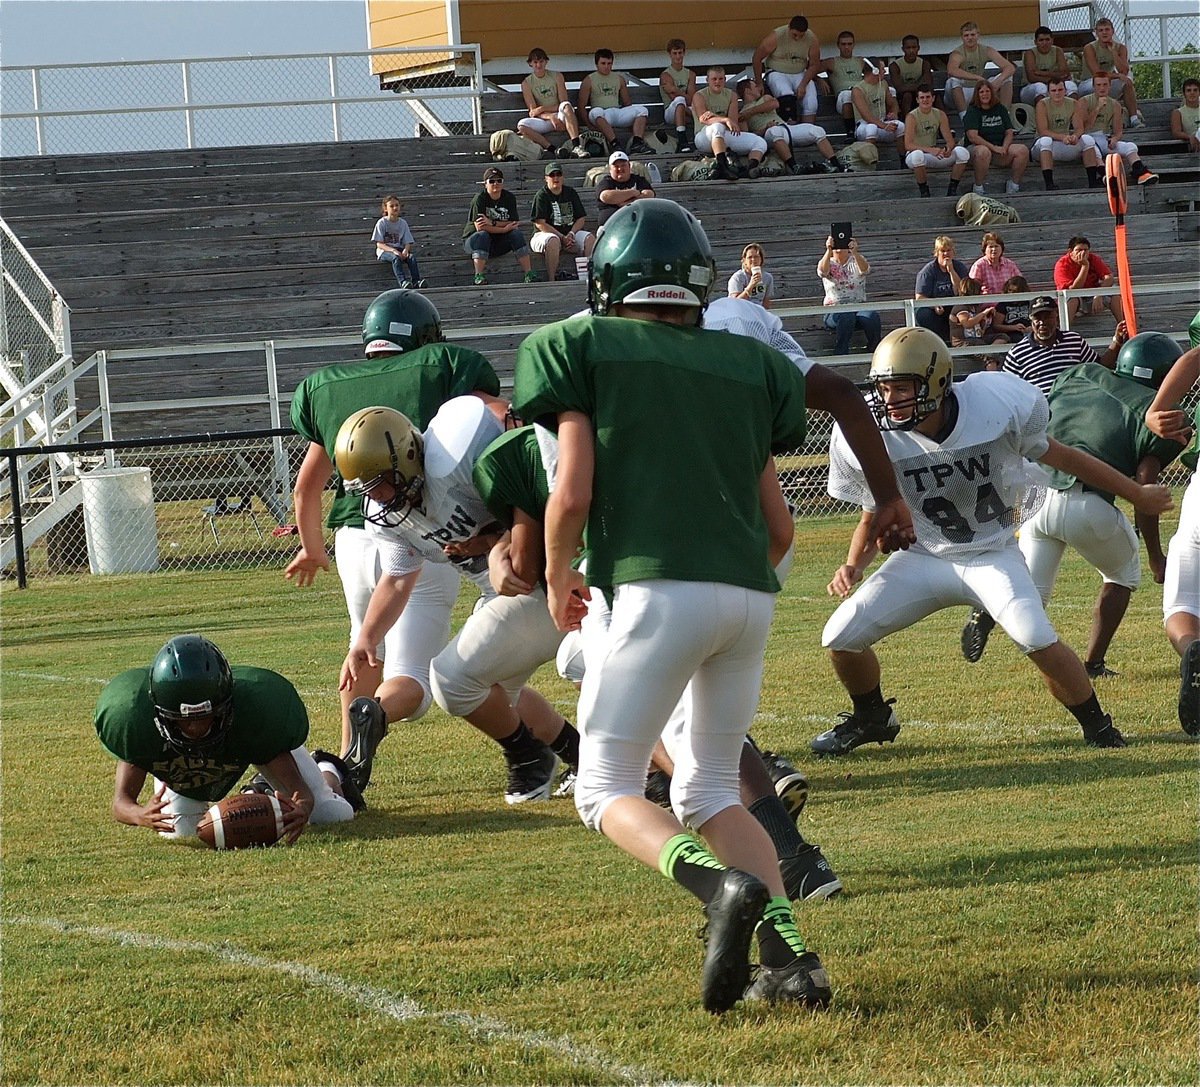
[334,396,578,804]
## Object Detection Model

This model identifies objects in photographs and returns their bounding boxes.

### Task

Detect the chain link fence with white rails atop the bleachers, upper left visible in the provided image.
[0,46,482,156]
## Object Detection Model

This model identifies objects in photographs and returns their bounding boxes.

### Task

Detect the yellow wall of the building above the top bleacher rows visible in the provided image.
[367,0,1040,61]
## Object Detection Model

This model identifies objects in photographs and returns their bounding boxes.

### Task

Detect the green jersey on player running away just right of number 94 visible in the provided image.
[1046,362,1183,502]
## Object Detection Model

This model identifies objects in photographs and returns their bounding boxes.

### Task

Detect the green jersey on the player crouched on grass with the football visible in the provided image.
[95,667,308,803]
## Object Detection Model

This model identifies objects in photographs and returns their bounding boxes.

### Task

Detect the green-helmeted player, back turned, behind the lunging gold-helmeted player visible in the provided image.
[284,290,504,789]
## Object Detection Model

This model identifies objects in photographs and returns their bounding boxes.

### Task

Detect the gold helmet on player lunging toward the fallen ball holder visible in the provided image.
[334,407,425,528]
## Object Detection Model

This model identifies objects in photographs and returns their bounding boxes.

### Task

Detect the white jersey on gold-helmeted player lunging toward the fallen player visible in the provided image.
[366,396,504,595]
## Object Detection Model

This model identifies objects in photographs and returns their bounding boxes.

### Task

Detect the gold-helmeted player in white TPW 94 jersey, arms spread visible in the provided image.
[811,328,1171,755]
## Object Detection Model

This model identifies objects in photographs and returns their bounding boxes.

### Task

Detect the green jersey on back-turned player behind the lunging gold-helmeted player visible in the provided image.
[292,343,500,528]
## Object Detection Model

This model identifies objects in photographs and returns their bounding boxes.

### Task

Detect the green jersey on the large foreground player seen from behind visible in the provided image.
[514,317,805,593]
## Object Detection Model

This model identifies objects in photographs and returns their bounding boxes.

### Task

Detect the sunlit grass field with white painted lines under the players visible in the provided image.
[2,518,1200,1085]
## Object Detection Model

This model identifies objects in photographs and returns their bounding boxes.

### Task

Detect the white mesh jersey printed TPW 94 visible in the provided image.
[829,373,1050,558]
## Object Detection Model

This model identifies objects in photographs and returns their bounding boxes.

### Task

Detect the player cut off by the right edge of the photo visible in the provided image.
[1146,345,1200,735]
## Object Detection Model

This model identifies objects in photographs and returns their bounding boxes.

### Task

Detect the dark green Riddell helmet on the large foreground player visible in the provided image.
[588,199,716,317]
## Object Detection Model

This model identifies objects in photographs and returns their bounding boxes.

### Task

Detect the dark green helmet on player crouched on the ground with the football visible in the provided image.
[150,635,233,752]
